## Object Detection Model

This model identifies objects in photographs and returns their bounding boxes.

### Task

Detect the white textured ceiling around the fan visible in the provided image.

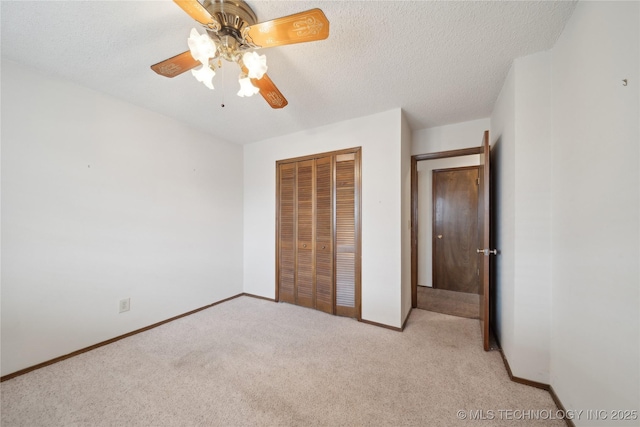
[1,0,575,144]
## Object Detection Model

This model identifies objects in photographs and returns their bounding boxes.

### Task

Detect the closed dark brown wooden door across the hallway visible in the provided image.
[432,166,480,294]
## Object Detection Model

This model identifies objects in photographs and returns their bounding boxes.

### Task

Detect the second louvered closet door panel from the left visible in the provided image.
[296,160,315,308]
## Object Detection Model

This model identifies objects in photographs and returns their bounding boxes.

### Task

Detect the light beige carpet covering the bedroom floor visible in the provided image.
[0,297,564,427]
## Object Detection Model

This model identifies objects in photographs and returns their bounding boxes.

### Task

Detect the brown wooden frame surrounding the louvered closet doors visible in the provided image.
[275,147,362,320]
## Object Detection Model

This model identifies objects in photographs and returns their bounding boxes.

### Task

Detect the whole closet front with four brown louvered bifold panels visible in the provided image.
[276,148,361,318]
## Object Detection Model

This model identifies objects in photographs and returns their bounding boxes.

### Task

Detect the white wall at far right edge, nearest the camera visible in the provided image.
[551,2,640,425]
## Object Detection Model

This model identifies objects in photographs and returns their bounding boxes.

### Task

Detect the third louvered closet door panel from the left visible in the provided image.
[316,156,334,313]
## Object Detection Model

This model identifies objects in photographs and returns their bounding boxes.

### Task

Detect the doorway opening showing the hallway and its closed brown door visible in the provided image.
[412,148,480,319]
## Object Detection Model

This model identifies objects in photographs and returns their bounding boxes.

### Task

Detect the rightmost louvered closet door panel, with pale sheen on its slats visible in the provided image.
[335,154,359,317]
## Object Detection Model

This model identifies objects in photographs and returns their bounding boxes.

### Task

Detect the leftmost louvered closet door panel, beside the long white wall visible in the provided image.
[278,163,297,304]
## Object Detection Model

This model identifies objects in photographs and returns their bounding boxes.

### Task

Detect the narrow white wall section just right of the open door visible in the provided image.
[509,52,552,384]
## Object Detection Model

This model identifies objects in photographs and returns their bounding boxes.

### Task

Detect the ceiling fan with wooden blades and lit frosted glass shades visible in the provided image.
[151,0,329,108]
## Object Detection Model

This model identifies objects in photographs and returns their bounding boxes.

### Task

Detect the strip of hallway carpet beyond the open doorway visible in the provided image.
[418,286,480,319]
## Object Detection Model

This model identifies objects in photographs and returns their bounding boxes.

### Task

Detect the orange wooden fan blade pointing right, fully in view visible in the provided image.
[245,9,329,47]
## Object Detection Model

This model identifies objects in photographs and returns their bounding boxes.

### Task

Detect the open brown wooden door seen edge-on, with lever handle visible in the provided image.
[477,131,497,351]
